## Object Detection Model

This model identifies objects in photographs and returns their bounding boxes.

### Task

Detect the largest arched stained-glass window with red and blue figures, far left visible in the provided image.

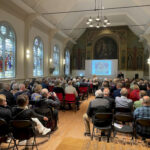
[0,22,16,78]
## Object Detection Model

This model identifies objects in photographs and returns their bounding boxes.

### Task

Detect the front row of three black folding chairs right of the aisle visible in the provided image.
[91,113,150,141]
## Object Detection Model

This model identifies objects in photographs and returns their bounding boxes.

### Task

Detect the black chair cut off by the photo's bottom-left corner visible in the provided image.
[0,118,11,149]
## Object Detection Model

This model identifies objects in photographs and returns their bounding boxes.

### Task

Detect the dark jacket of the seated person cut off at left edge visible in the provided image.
[0,106,12,122]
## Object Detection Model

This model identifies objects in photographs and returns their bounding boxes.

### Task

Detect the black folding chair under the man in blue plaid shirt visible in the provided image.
[135,119,150,139]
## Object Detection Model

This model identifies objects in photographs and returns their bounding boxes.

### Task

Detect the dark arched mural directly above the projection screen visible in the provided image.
[94,37,118,59]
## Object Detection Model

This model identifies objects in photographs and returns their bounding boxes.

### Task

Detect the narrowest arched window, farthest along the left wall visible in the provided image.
[65,51,70,75]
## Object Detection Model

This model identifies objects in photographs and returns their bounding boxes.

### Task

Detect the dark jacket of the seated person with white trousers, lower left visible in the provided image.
[12,107,43,120]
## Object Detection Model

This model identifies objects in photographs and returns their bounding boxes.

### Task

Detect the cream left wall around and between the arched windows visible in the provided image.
[0,9,64,80]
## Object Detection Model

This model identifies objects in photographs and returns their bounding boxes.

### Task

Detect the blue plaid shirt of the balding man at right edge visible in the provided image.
[134,106,150,135]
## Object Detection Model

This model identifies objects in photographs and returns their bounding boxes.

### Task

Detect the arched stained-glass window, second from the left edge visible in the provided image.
[33,37,43,76]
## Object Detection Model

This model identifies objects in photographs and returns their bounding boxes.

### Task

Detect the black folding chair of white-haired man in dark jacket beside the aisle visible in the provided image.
[91,113,113,142]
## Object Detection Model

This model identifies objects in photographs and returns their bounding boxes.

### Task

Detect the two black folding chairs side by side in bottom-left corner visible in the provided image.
[0,119,43,150]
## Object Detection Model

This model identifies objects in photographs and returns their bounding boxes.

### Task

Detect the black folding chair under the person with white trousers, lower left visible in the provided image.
[11,120,38,150]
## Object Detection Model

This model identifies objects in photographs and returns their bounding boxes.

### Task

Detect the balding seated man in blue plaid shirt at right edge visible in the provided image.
[134,96,150,136]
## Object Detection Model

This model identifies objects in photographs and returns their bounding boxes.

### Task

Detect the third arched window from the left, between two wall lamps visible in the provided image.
[53,45,60,75]
